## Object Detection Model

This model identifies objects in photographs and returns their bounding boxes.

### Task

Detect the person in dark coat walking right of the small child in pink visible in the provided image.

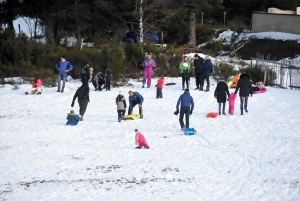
[234,73,253,115]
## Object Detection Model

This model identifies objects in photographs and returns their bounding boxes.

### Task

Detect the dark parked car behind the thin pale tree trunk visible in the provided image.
[122,31,168,51]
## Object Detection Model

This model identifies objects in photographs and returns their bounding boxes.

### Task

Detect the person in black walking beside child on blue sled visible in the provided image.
[71,82,90,121]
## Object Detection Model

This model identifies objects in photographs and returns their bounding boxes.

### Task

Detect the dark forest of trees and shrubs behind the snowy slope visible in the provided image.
[0,0,299,83]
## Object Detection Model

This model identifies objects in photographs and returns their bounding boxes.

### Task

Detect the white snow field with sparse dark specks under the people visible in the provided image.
[0,78,300,201]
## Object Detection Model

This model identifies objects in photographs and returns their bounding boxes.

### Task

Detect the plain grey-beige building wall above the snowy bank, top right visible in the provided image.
[252,12,300,35]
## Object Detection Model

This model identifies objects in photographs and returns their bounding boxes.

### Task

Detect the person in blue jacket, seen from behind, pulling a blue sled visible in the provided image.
[176,89,194,130]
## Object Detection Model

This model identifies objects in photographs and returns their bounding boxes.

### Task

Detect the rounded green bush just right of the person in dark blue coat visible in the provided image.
[213,62,234,82]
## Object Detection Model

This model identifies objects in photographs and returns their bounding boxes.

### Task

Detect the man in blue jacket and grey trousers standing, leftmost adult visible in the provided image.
[55,56,73,93]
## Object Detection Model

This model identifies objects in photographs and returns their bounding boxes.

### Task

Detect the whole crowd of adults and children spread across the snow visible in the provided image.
[26,54,263,148]
